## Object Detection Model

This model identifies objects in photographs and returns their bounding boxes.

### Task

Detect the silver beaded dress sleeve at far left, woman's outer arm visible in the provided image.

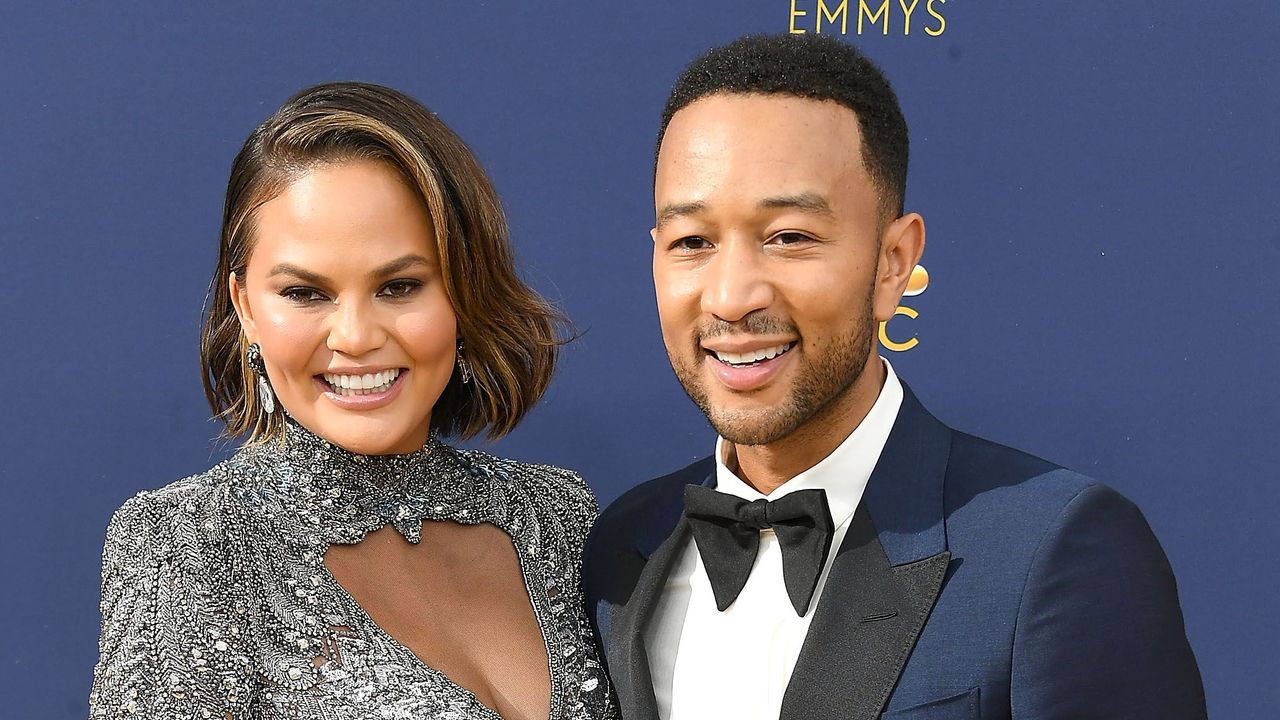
[90,491,251,720]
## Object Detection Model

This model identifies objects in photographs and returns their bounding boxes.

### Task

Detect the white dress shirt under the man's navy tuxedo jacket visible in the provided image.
[644,361,902,720]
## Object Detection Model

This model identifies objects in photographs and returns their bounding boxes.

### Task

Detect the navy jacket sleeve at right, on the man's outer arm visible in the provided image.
[1010,486,1206,720]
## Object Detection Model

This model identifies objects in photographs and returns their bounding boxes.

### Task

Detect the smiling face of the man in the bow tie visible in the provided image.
[653,94,914,445]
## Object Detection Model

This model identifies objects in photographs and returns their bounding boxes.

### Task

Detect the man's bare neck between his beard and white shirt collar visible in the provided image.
[724,355,886,495]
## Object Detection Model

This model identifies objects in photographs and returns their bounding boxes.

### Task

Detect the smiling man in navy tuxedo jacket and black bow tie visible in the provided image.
[586,35,1204,720]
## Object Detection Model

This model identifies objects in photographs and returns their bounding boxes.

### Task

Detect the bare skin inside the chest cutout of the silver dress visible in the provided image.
[324,520,557,720]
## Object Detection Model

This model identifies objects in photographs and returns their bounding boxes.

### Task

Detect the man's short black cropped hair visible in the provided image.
[658,33,909,218]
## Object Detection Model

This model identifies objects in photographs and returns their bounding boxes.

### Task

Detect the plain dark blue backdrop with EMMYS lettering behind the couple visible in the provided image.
[0,0,1280,719]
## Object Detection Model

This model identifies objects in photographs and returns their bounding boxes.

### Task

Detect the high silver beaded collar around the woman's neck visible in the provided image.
[249,418,495,544]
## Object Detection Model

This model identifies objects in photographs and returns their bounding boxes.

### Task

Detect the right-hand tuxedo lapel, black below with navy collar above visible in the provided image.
[782,384,951,720]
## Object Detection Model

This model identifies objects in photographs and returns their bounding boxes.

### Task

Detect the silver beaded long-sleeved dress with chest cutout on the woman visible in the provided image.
[90,423,616,720]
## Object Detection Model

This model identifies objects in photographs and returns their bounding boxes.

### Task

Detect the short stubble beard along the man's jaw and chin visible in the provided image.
[667,284,876,445]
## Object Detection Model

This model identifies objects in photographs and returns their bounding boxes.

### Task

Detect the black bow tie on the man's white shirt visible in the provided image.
[685,486,835,616]
